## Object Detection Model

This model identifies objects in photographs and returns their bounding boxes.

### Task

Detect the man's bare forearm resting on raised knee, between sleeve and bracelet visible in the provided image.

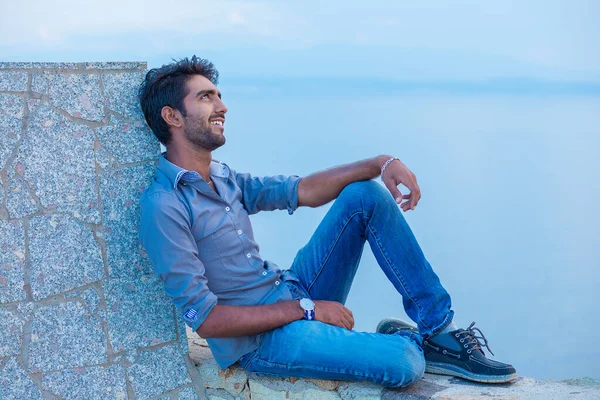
[298,155,390,207]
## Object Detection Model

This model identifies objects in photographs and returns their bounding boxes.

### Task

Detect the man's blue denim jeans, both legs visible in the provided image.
[239,181,454,387]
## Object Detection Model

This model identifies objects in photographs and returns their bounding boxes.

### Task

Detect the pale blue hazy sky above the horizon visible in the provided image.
[0,0,600,85]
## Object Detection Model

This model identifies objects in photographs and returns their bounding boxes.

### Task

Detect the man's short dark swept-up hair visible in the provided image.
[138,56,219,145]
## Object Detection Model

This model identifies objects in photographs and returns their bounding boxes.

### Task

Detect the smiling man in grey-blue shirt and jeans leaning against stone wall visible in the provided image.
[139,56,517,387]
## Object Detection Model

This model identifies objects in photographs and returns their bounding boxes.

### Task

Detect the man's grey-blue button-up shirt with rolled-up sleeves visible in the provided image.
[140,154,301,368]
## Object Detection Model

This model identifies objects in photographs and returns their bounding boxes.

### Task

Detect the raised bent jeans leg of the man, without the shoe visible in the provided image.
[286,181,453,336]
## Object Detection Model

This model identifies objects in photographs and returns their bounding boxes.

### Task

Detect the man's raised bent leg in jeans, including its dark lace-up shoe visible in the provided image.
[282,181,517,383]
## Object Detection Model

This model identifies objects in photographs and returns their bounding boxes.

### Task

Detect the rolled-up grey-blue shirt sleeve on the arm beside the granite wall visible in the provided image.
[140,192,217,331]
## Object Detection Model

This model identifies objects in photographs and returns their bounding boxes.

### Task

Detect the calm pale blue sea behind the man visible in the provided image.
[214,85,600,379]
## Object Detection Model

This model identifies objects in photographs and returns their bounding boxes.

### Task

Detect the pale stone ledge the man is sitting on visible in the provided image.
[189,334,600,400]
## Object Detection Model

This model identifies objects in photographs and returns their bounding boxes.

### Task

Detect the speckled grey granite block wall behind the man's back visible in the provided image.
[0,62,199,399]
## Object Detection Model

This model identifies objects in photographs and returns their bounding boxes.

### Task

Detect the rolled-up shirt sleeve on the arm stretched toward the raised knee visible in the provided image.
[232,171,302,215]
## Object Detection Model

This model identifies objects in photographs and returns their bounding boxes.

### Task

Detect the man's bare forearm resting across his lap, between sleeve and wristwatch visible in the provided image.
[196,301,304,338]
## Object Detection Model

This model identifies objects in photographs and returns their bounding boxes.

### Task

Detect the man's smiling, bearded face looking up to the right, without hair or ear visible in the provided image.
[183,75,227,151]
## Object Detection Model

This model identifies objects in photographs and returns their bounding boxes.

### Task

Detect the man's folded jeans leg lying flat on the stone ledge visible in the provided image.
[240,320,425,387]
